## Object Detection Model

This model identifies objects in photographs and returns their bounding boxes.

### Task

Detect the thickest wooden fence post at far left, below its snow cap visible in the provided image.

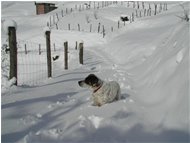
[8,27,17,85]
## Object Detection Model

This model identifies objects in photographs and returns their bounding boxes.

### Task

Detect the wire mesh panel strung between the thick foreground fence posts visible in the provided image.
[17,40,67,86]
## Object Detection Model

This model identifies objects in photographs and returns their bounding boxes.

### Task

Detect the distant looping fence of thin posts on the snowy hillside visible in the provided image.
[47,1,168,37]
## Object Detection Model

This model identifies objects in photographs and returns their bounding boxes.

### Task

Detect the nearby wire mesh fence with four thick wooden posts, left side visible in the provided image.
[7,27,83,86]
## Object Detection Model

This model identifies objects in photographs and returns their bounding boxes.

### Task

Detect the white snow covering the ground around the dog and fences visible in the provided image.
[1,1,190,143]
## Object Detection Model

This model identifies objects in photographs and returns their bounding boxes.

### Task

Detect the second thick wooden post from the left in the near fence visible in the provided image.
[45,31,52,78]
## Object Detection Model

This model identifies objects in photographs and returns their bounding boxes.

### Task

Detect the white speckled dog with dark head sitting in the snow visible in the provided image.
[78,74,120,106]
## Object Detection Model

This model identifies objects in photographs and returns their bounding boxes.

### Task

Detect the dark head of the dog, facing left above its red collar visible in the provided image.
[78,74,102,89]
